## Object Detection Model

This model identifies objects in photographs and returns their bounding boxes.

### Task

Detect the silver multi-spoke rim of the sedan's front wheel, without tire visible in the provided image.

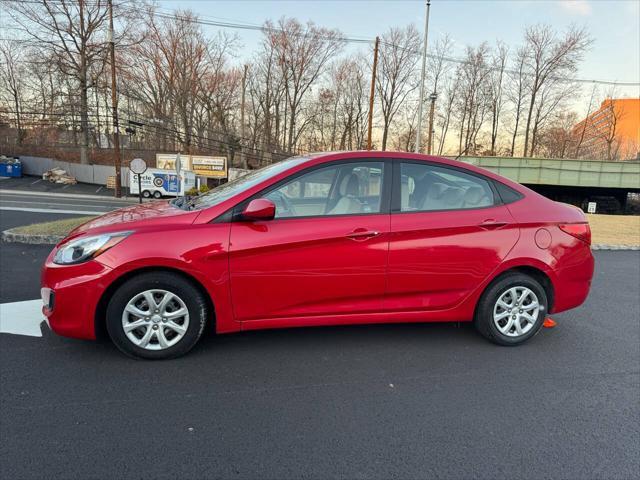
[122,289,189,350]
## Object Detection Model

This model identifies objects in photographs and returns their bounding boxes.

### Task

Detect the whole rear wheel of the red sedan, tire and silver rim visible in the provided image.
[474,272,548,345]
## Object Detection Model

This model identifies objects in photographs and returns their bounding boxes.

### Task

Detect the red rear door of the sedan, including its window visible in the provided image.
[385,161,519,311]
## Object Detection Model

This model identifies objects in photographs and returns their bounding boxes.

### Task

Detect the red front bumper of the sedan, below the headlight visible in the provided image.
[41,250,112,339]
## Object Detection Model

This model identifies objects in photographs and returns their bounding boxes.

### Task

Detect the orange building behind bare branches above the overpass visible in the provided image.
[571,98,640,160]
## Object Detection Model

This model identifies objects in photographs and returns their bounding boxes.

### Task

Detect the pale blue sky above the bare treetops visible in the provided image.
[160,0,640,96]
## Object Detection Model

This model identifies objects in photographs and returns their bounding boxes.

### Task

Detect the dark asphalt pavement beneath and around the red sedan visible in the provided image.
[0,208,640,479]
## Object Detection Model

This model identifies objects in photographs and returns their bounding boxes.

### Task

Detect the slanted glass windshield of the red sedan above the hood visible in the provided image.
[189,157,309,210]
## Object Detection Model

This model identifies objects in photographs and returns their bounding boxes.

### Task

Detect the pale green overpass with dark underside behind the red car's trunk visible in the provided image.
[460,157,640,213]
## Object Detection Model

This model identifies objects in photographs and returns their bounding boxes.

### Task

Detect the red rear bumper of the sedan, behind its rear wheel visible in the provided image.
[551,244,595,313]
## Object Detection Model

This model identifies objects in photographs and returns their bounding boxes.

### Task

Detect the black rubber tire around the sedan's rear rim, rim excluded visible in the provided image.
[474,272,549,346]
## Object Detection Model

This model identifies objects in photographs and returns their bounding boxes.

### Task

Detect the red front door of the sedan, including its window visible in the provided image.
[229,160,390,325]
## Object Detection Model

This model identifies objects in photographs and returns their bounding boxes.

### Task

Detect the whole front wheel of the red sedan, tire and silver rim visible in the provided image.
[107,272,207,359]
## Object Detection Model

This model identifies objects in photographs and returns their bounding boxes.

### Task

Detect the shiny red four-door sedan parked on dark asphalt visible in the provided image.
[42,152,594,358]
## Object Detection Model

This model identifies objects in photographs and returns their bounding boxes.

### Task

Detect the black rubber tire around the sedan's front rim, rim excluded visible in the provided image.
[106,272,208,359]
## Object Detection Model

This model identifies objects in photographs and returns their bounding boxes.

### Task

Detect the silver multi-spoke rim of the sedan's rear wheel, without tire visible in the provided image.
[493,286,540,338]
